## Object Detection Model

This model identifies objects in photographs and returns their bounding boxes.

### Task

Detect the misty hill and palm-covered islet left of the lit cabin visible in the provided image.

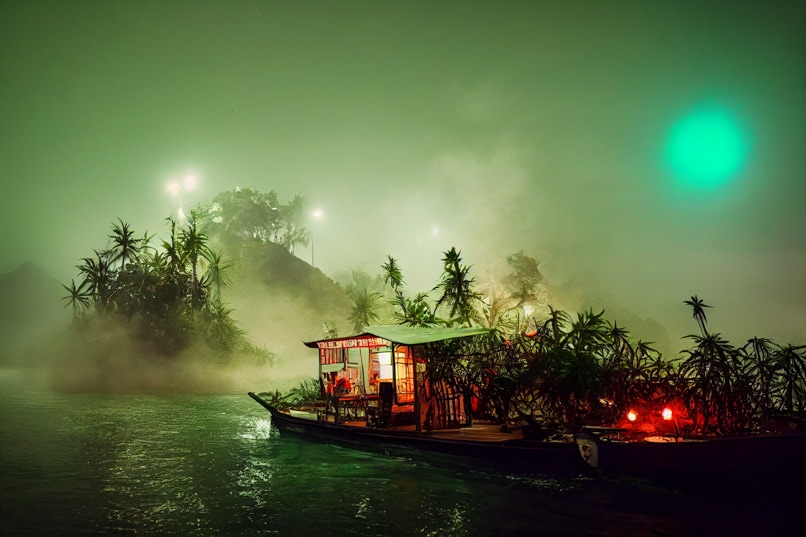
[57,188,347,391]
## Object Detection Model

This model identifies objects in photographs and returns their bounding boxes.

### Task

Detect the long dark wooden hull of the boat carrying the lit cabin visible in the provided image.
[249,392,593,477]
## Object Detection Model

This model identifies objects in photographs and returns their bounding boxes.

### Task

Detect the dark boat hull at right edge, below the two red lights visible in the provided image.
[576,427,806,490]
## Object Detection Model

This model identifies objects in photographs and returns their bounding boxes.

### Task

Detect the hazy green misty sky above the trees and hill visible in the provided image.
[0,0,806,344]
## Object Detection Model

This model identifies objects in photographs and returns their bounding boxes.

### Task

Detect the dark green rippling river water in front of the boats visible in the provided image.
[0,370,806,537]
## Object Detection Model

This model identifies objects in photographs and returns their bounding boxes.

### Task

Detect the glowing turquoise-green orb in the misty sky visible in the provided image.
[666,107,747,187]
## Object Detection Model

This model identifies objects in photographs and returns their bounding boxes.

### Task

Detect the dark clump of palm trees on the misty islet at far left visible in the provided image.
[63,212,270,359]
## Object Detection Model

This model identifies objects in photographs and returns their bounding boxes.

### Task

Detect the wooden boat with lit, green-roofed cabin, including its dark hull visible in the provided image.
[249,325,604,475]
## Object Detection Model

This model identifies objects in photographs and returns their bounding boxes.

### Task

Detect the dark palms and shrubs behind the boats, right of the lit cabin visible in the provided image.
[334,248,806,435]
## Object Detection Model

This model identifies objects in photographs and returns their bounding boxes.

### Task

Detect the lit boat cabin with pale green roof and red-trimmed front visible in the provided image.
[305,325,487,431]
